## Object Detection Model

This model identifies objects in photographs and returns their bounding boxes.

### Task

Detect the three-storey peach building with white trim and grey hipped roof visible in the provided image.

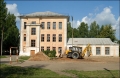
[19,11,69,56]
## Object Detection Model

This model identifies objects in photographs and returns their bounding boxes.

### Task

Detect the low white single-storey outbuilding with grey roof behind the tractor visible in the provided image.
[67,38,119,56]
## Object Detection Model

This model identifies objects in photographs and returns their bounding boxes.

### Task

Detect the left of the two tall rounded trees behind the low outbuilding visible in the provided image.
[78,22,88,38]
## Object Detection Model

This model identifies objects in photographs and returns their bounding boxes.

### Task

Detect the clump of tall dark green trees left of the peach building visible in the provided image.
[0,0,19,54]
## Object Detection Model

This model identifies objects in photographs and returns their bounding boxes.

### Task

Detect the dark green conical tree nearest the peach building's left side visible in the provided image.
[3,13,19,50]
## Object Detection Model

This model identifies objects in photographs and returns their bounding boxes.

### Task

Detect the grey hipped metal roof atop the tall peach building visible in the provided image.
[19,11,67,16]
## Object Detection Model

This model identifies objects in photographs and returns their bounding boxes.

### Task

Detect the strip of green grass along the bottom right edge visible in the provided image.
[63,70,120,78]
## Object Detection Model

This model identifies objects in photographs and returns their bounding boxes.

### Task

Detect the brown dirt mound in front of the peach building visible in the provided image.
[28,52,50,61]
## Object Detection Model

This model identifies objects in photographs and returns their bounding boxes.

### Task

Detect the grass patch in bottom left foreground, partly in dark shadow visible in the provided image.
[0,64,70,78]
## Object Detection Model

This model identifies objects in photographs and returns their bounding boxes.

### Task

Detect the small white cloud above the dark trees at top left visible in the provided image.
[6,3,20,21]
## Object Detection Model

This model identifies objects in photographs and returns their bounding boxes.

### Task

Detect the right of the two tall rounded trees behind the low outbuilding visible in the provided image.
[89,21,100,38]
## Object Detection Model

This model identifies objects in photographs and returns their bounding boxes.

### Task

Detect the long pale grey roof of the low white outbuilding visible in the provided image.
[67,38,116,45]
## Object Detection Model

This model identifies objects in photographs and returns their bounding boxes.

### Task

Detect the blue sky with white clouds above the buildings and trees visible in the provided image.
[5,0,120,39]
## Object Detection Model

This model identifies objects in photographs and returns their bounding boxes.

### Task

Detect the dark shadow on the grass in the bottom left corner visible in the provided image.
[0,64,46,78]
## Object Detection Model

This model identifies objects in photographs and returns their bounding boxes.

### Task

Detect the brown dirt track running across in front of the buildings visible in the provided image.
[1,57,120,77]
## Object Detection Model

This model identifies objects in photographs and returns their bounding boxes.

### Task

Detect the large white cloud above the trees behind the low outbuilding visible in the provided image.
[76,6,120,38]
